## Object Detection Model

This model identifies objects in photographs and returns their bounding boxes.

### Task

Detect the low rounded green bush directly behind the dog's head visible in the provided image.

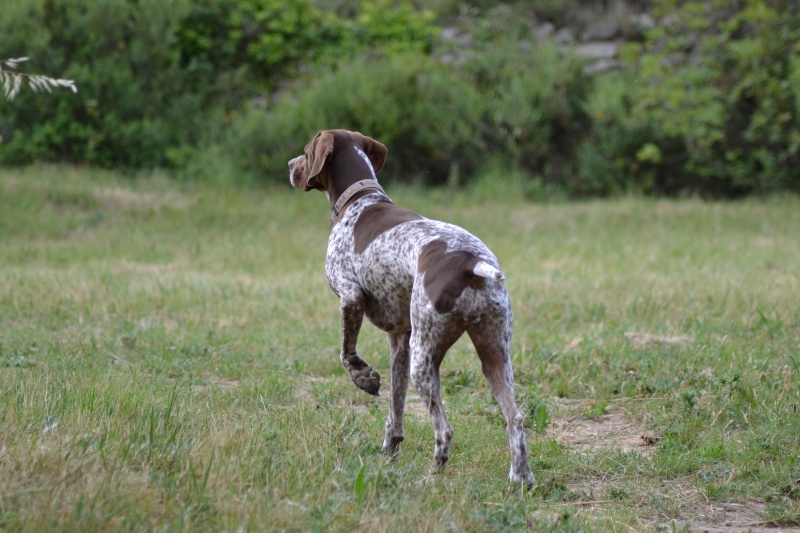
[224,53,484,184]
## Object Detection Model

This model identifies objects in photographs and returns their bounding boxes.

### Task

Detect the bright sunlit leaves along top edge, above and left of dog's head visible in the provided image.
[176,0,438,82]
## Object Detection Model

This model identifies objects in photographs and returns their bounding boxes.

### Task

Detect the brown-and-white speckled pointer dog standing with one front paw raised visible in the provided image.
[289,130,534,486]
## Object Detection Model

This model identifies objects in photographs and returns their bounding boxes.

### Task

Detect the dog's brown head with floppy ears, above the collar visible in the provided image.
[289,130,387,197]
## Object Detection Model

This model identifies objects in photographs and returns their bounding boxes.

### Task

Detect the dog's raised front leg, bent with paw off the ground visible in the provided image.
[339,288,381,396]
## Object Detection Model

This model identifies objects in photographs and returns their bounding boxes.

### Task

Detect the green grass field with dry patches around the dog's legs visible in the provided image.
[0,167,800,531]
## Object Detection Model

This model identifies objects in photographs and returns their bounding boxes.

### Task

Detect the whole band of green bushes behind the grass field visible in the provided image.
[0,0,800,196]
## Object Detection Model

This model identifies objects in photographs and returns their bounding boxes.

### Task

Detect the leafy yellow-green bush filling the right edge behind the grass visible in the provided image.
[628,0,800,194]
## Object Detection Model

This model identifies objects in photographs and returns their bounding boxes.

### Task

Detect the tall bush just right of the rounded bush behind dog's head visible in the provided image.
[437,2,592,194]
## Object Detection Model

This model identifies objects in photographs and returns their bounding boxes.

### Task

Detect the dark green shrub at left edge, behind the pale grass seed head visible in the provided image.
[0,0,201,166]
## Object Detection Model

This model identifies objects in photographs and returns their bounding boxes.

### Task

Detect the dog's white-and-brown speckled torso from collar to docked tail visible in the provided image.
[328,194,505,332]
